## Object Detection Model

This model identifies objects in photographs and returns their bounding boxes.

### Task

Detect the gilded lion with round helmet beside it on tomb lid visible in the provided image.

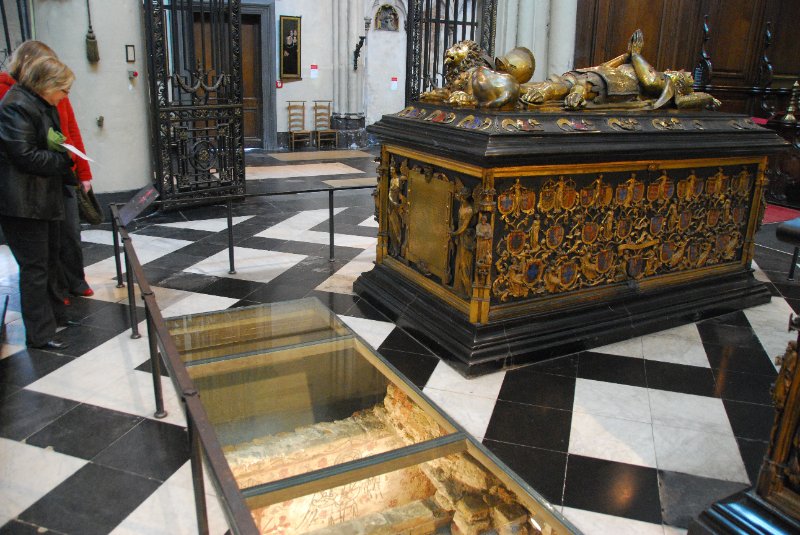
[420,40,535,109]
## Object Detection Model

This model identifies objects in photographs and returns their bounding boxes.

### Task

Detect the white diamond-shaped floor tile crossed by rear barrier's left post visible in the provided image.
[184,247,306,283]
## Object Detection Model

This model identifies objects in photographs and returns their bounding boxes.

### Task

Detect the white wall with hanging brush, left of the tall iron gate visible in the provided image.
[34,0,153,193]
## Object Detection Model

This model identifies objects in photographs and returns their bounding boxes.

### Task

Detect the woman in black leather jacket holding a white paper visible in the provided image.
[0,56,75,350]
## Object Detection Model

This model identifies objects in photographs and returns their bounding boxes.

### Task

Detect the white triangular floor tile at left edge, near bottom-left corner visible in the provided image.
[0,438,87,521]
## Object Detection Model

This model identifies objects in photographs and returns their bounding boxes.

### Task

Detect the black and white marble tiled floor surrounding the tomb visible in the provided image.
[0,149,800,535]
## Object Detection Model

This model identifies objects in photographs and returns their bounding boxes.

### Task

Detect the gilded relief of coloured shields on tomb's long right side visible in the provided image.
[492,165,757,302]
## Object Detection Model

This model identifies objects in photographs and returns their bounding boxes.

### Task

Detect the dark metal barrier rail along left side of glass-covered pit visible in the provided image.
[111,205,259,535]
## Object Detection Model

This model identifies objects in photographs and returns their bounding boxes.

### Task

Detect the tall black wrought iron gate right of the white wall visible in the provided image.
[144,0,245,207]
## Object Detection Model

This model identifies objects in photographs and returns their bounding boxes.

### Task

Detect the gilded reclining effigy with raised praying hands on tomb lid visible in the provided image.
[520,30,721,110]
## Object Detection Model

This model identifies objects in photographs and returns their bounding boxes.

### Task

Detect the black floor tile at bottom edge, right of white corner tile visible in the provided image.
[19,463,159,535]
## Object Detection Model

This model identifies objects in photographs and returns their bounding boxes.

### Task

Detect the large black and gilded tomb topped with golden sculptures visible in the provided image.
[354,32,786,375]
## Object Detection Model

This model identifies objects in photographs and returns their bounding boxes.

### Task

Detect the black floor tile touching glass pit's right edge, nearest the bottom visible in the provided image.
[483,440,567,505]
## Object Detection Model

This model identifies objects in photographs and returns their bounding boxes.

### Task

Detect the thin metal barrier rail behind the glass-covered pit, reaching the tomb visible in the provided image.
[109,185,376,339]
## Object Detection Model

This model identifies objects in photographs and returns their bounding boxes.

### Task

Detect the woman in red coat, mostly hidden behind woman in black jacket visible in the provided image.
[0,41,94,302]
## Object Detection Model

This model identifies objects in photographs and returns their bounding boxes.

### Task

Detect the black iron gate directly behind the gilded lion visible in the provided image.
[406,0,497,102]
